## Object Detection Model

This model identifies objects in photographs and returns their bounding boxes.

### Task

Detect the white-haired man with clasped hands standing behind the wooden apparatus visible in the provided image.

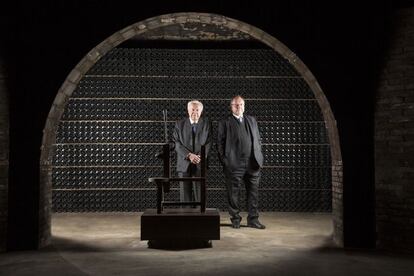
[173,100,211,202]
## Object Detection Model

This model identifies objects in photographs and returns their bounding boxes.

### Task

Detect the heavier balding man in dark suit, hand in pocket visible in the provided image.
[217,96,265,229]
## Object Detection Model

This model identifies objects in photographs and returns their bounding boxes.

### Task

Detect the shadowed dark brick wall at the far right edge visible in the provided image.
[375,5,414,253]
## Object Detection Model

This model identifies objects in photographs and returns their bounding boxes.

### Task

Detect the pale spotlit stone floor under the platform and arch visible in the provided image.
[0,212,414,276]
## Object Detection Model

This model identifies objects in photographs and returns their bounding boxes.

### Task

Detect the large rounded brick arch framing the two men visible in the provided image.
[39,12,343,247]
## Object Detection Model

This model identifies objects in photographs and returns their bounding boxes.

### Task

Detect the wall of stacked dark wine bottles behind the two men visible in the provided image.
[52,48,332,212]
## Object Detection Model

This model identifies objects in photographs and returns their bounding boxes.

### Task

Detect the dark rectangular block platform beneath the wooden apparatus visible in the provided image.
[141,208,220,241]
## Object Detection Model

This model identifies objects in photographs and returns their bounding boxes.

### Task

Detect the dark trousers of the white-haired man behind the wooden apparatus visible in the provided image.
[178,164,201,202]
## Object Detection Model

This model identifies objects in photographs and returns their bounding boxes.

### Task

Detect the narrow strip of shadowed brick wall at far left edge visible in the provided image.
[0,55,9,252]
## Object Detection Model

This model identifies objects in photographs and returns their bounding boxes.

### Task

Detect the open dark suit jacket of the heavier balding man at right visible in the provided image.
[217,115,263,171]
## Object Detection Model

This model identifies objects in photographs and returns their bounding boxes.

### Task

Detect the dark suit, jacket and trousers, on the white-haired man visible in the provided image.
[173,117,211,201]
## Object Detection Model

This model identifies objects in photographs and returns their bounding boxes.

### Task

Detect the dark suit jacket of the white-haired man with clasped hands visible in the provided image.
[173,117,211,172]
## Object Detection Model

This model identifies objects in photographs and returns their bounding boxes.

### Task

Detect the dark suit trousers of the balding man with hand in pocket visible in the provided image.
[224,160,260,222]
